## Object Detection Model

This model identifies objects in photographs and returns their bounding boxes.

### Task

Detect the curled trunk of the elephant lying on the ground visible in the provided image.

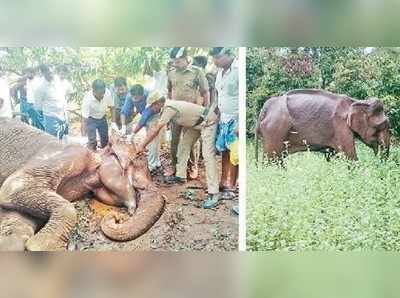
[100,190,165,241]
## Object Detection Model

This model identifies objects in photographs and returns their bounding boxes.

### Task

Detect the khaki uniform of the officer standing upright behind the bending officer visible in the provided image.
[168,65,208,167]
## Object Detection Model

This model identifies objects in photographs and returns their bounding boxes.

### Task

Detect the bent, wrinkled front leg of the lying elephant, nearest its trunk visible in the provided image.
[3,188,77,251]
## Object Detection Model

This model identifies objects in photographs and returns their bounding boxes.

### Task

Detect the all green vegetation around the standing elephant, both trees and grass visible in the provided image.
[246,48,400,251]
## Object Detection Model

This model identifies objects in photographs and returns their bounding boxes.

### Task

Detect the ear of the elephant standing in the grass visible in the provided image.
[347,101,370,139]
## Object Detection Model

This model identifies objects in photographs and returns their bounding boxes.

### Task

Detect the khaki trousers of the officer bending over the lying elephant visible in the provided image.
[176,123,219,194]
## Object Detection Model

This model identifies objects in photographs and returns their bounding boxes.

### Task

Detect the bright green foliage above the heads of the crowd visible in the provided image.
[0,47,216,103]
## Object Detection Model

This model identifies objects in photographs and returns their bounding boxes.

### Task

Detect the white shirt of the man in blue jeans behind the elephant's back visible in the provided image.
[35,80,66,120]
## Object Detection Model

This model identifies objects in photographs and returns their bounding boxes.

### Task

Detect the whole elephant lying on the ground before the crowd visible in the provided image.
[0,119,165,250]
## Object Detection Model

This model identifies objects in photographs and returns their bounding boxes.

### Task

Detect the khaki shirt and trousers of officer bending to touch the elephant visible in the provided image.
[159,100,219,194]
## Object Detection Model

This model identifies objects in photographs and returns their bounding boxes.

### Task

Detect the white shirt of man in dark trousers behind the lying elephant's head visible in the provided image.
[82,89,114,119]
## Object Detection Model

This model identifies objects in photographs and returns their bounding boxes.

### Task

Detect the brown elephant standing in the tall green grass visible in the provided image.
[256,89,390,160]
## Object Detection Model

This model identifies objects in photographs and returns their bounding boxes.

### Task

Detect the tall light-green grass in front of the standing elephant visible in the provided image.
[246,141,400,251]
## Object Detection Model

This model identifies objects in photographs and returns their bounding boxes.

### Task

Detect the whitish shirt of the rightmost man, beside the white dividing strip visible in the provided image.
[215,59,239,123]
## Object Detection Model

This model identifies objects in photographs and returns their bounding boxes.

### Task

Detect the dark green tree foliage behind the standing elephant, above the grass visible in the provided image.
[246,47,400,137]
